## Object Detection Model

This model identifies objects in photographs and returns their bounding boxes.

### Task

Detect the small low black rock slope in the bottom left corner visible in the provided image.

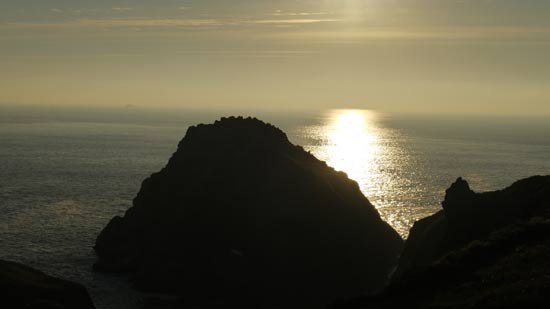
[0,261,94,309]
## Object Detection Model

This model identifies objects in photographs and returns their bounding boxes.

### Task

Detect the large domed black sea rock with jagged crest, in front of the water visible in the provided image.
[94,117,402,308]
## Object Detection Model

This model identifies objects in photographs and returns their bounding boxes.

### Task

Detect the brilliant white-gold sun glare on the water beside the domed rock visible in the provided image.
[302,109,426,237]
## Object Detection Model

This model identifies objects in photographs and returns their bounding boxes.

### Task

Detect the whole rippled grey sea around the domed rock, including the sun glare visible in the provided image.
[0,108,550,308]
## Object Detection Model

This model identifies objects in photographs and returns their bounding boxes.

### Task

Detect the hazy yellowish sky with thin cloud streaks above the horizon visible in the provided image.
[0,0,550,115]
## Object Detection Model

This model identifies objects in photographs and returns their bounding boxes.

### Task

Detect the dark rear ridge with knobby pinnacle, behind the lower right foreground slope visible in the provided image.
[396,176,550,276]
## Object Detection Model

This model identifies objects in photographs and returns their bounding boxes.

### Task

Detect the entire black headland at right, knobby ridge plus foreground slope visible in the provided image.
[333,176,550,308]
